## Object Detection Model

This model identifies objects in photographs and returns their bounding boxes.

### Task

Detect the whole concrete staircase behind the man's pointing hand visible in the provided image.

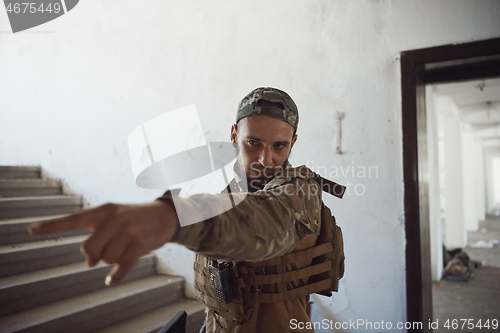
[0,166,204,333]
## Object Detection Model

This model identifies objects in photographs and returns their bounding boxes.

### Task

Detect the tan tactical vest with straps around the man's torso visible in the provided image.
[194,198,345,324]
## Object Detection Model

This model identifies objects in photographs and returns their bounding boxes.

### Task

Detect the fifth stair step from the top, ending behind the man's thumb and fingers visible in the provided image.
[0,235,87,277]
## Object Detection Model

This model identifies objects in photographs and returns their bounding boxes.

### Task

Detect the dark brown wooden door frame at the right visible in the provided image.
[400,38,500,332]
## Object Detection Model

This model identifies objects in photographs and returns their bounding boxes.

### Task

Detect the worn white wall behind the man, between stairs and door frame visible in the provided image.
[0,0,500,331]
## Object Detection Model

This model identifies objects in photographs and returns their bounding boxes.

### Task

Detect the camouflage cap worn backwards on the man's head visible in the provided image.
[236,87,299,130]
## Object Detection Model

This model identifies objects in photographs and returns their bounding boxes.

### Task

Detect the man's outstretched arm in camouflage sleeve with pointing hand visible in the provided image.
[30,174,321,285]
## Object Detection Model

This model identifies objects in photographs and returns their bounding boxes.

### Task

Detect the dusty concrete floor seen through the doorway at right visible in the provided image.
[432,216,500,332]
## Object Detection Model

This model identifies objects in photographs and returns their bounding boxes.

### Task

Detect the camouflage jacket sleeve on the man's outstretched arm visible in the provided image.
[159,178,321,262]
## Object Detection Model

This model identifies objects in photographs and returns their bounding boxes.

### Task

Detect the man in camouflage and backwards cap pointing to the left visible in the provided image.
[30,88,343,332]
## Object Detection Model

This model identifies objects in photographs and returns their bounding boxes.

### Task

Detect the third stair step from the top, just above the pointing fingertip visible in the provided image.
[0,195,82,219]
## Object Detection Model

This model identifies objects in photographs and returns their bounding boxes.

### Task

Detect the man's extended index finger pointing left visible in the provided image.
[28,204,115,235]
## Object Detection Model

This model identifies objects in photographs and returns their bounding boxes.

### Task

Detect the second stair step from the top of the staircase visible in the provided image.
[0,179,62,198]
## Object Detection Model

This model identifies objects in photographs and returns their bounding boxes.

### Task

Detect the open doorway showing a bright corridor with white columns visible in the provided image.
[426,78,500,333]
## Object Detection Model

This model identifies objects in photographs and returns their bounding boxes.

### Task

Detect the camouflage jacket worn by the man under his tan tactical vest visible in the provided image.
[157,164,322,333]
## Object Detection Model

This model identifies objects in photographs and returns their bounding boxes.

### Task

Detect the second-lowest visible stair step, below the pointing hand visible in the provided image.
[0,275,183,333]
